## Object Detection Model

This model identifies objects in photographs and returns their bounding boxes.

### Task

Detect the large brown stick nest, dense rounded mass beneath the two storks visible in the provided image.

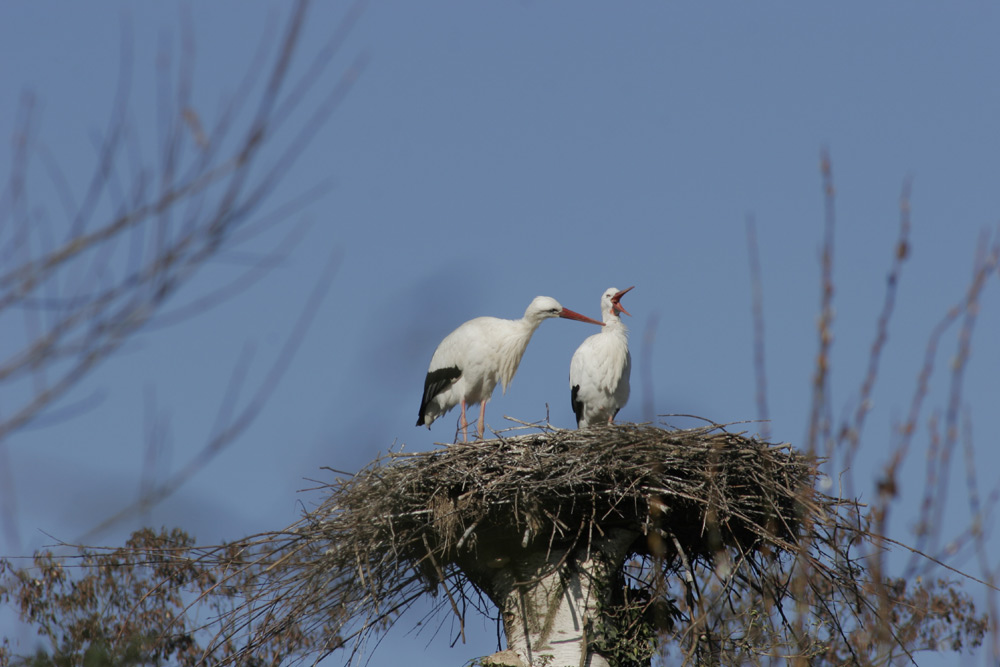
[344,425,818,566]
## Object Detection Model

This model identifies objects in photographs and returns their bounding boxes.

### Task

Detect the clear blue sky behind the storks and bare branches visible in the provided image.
[0,0,1000,664]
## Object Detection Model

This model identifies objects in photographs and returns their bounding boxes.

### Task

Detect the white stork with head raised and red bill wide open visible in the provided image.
[569,285,635,428]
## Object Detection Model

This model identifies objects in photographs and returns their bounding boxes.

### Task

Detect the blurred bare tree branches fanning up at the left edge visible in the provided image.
[0,0,364,544]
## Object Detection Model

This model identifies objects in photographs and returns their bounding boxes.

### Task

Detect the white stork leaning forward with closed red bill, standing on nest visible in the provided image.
[417,296,601,441]
